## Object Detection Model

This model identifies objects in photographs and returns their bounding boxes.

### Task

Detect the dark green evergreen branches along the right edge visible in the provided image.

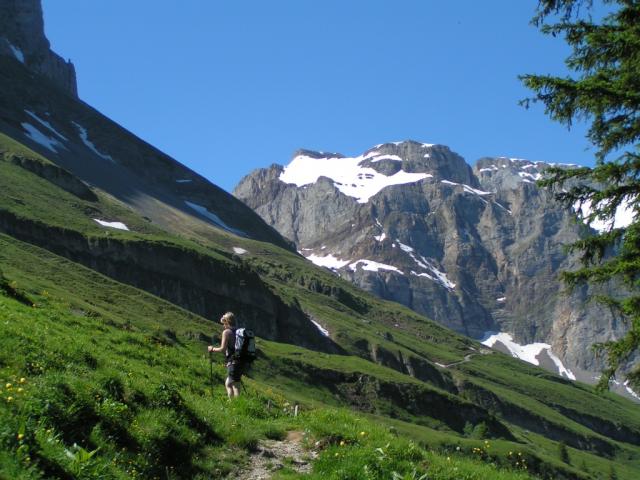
[520,0,640,388]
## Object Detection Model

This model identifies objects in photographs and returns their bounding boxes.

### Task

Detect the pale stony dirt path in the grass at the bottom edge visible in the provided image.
[234,432,317,480]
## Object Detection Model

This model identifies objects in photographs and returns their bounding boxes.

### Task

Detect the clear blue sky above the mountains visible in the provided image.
[43,0,592,191]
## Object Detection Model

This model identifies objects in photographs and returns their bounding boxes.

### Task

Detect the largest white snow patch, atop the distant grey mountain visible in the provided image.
[279,153,433,203]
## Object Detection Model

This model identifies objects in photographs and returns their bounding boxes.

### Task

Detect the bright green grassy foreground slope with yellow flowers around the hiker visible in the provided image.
[0,236,526,479]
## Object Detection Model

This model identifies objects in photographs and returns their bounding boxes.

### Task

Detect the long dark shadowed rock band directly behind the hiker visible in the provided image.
[0,209,342,353]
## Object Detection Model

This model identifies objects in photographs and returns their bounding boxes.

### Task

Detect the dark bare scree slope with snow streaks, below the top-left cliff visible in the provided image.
[0,56,291,248]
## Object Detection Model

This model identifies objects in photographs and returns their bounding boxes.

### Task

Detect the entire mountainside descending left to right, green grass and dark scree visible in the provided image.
[0,3,640,480]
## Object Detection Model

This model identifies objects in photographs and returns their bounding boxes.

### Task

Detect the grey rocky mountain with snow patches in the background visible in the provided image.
[234,141,636,382]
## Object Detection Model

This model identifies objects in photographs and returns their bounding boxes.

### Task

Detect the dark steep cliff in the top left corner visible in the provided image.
[0,0,78,97]
